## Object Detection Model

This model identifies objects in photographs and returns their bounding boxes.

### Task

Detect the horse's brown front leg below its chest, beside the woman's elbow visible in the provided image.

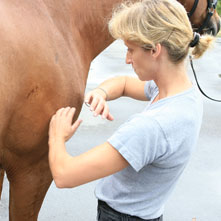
[6,147,52,221]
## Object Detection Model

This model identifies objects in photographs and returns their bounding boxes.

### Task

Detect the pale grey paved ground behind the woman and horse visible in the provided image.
[0,39,221,221]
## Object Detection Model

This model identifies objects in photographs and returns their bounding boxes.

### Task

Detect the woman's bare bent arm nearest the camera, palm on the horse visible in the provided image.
[49,108,128,188]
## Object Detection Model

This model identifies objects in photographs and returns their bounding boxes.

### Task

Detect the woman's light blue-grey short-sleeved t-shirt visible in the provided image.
[95,81,203,219]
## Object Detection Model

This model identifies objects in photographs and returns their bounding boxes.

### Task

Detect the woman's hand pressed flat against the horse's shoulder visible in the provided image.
[49,107,82,142]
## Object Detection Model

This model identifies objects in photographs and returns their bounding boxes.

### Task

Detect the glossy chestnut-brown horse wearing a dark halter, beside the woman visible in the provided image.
[0,0,219,221]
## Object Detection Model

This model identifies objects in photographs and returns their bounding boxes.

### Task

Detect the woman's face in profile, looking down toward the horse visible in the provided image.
[124,41,153,81]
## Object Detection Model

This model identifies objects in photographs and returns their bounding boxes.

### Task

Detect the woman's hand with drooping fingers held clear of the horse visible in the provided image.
[85,88,114,121]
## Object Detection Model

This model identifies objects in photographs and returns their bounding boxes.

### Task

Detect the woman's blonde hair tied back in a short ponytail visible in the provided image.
[109,0,213,63]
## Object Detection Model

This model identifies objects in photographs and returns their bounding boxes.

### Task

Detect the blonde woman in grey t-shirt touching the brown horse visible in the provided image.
[49,0,213,221]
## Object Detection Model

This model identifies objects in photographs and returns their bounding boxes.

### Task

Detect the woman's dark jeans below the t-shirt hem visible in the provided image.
[97,200,163,221]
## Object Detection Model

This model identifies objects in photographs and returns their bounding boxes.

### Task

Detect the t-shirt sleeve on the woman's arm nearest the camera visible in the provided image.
[108,114,167,172]
